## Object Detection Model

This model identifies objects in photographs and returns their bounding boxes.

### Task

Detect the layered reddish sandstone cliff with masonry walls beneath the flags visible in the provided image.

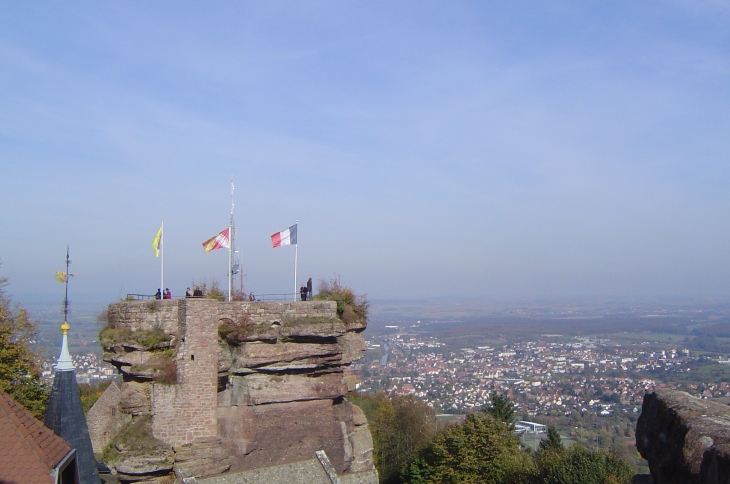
[99,299,373,482]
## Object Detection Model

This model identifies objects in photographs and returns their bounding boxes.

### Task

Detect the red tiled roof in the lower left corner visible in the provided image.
[0,390,71,484]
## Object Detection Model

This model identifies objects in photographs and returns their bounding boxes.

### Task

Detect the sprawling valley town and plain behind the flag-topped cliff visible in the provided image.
[32,301,730,472]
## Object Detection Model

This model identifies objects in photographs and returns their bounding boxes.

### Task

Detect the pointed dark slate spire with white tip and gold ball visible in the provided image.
[45,322,99,484]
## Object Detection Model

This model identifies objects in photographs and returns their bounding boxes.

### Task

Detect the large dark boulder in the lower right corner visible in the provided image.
[636,390,730,484]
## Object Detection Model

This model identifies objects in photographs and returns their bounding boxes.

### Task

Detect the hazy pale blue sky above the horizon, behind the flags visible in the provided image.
[0,0,730,302]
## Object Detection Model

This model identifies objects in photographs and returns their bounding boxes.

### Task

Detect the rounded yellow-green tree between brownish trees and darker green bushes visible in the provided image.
[401,412,537,484]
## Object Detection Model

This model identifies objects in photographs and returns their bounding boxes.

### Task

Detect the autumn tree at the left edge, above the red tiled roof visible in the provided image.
[0,270,49,420]
